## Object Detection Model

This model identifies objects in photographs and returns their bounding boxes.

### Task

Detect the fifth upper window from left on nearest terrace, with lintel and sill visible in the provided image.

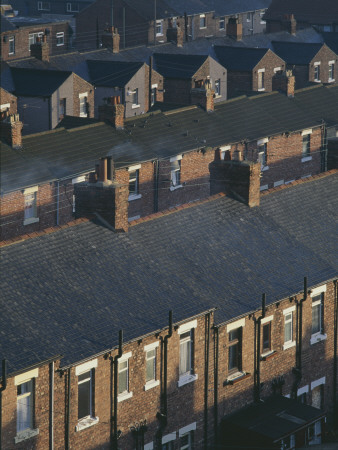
[178,320,197,387]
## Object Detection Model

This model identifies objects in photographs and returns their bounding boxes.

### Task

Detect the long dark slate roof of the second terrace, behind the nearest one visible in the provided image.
[1,85,338,192]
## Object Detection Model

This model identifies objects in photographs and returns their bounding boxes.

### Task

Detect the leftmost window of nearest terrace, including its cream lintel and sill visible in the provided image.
[14,369,39,444]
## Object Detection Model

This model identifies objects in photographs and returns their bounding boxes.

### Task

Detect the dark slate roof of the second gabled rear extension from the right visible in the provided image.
[214,45,268,72]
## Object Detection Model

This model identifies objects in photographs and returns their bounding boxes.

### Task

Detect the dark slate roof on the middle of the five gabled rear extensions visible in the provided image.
[154,53,208,79]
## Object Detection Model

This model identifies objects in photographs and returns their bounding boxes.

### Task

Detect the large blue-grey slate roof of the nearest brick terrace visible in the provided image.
[0,174,338,373]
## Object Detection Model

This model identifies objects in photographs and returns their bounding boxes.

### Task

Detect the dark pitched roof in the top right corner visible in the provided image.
[265,0,338,24]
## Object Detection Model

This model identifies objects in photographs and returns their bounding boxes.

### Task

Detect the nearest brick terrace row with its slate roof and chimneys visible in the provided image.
[0,167,338,450]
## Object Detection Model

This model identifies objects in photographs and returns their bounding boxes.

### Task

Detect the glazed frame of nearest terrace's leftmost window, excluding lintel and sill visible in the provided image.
[16,379,34,433]
